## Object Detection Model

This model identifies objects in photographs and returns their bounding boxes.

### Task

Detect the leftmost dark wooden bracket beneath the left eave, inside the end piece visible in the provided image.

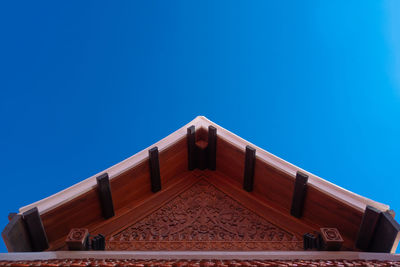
[23,207,49,252]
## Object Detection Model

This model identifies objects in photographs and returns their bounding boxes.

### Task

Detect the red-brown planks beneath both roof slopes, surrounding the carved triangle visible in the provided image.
[36,131,362,250]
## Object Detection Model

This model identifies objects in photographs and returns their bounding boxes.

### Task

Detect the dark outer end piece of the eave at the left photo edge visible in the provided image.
[1,214,32,252]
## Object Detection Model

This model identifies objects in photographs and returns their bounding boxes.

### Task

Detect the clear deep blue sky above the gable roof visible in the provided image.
[0,0,400,254]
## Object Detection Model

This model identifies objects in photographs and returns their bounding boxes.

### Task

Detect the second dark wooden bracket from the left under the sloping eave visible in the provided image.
[96,173,115,219]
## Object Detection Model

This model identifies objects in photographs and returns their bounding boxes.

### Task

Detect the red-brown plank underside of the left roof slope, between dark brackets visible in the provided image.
[41,138,187,249]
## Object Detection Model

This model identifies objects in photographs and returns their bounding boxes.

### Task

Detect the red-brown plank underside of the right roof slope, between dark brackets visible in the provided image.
[217,138,362,250]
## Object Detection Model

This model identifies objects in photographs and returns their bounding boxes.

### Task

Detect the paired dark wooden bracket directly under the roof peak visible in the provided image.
[186,125,217,171]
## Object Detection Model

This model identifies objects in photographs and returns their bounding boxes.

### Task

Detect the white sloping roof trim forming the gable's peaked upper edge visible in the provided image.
[19,116,389,216]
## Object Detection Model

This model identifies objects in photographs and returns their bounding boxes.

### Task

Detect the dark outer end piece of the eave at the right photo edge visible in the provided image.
[368,211,400,253]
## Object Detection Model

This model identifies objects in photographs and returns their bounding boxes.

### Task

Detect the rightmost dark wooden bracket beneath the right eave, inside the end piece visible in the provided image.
[356,206,381,251]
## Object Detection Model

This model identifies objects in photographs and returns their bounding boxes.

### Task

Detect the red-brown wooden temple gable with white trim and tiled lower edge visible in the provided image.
[0,116,400,266]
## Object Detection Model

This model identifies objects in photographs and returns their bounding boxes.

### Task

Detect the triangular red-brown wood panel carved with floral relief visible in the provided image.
[106,180,303,250]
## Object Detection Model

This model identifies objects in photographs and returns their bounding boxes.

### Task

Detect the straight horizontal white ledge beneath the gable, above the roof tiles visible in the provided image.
[0,251,400,261]
